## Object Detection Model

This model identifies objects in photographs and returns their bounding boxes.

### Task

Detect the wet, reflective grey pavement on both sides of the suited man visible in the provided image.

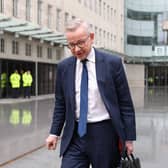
[0,88,168,168]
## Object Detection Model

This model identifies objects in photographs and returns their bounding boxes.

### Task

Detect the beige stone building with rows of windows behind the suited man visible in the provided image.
[0,0,124,98]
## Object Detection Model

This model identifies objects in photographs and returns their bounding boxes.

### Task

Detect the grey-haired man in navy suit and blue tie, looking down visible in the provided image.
[46,19,136,168]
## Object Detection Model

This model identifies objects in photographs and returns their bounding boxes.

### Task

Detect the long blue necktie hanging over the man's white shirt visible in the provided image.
[78,59,88,137]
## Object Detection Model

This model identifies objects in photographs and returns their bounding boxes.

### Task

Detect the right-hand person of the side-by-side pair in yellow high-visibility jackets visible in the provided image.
[22,70,33,98]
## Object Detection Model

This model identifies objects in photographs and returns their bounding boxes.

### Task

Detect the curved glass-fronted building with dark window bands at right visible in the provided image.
[125,0,168,87]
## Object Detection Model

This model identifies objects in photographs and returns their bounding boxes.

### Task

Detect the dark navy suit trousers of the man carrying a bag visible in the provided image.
[61,120,120,168]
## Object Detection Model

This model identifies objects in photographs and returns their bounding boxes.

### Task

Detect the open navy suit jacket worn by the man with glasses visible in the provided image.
[50,49,136,155]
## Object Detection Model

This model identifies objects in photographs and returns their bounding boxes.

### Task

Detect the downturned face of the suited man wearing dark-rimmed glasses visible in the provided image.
[66,26,94,60]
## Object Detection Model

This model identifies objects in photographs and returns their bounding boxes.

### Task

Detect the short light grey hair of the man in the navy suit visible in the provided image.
[65,18,92,34]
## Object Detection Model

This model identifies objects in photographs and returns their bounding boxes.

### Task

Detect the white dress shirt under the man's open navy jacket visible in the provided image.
[75,48,110,123]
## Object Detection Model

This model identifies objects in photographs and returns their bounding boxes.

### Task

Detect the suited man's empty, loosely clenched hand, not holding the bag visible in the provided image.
[46,135,58,150]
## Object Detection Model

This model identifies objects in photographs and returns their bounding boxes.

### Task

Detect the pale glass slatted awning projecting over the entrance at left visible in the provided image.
[0,14,67,45]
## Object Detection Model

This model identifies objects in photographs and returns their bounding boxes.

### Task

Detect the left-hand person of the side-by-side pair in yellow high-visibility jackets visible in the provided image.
[10,70,21,98]
